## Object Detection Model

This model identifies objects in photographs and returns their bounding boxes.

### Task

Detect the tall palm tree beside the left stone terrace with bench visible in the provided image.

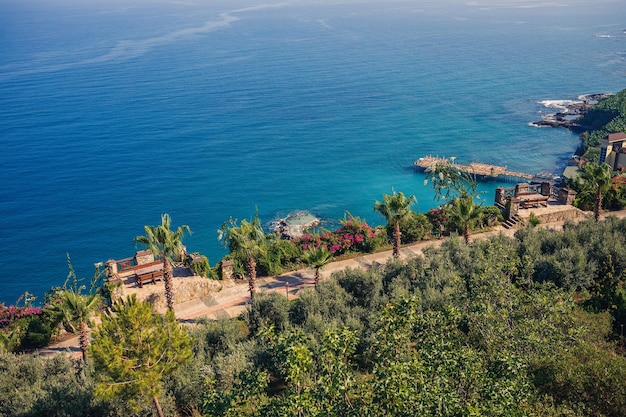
[135,214,191,311]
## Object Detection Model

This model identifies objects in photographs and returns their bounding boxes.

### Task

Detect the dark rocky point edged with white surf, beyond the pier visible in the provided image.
[530,93,611,131]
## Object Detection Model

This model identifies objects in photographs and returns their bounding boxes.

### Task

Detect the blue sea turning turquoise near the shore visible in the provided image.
[0,0,626,305]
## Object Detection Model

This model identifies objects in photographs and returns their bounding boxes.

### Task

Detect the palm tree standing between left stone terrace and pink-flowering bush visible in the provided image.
[218,210,265,301]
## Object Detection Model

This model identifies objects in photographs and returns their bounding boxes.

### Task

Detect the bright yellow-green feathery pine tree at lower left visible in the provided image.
[89,296,192,412]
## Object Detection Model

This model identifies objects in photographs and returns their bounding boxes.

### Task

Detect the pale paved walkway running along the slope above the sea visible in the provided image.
[39,206,626,356]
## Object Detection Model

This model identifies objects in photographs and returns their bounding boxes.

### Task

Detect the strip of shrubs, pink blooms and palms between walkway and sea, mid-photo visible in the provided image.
[220,204,502,277]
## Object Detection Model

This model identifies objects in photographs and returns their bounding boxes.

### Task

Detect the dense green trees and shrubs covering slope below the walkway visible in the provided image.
[0,218,626,417]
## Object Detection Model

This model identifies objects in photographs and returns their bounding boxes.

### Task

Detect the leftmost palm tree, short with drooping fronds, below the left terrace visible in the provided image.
[51,255,102,362]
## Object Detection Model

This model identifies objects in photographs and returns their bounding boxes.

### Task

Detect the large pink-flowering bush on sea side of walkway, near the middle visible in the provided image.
[294,216,382,256]
